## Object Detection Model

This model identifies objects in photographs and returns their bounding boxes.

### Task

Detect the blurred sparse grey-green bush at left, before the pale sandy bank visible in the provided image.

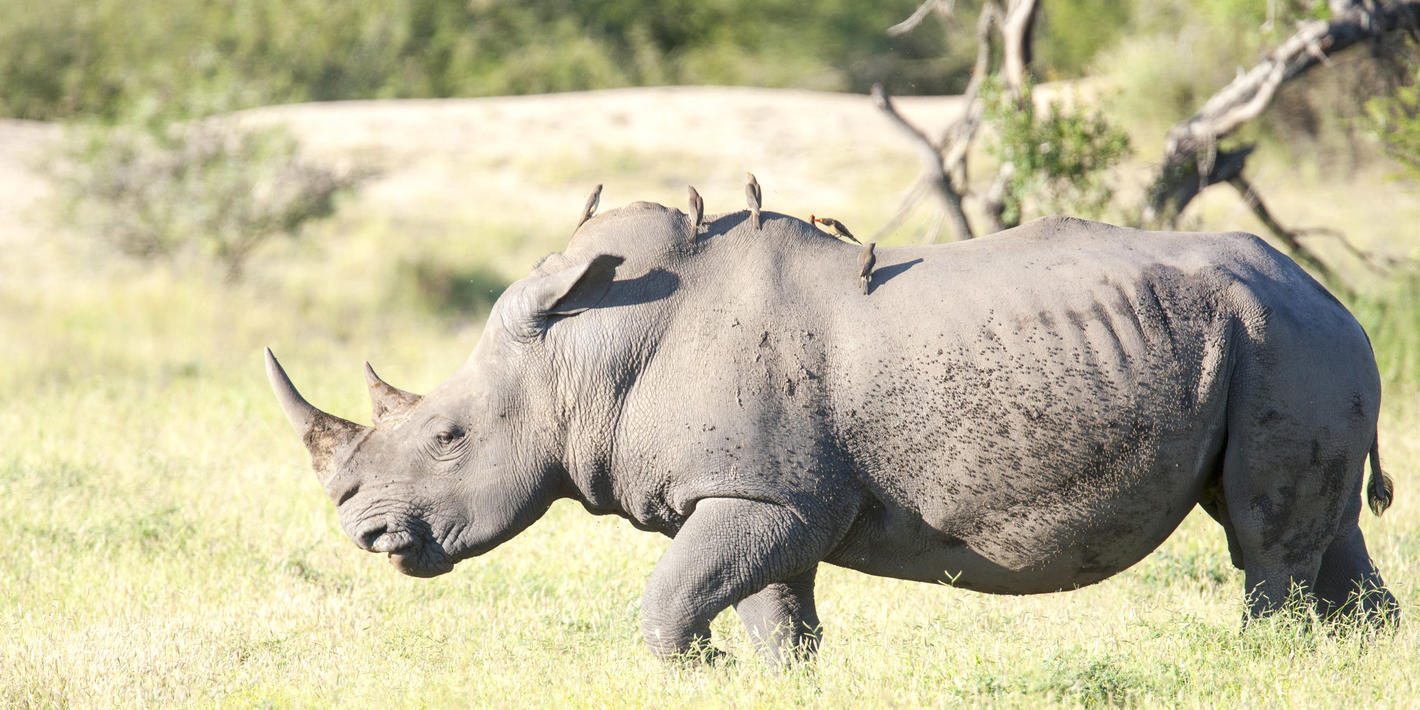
[50,116,361,281]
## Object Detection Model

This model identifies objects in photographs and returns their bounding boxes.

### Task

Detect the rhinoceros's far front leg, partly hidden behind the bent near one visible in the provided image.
[734,565,821,663]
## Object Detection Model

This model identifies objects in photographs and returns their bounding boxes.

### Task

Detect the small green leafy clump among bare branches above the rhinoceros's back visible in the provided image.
[983,81,1130,224]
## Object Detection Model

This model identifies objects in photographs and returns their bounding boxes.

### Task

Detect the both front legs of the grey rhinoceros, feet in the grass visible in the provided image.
[640,498,838,659]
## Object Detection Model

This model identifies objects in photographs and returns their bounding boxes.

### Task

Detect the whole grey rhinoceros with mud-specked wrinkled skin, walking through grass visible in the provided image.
[267,203,1397,659]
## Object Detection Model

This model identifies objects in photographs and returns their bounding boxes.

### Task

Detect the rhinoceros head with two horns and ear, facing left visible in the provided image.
[266,254,622,577]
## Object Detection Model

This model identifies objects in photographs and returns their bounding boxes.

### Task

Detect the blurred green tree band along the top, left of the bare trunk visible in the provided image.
[0,0,970,119]
